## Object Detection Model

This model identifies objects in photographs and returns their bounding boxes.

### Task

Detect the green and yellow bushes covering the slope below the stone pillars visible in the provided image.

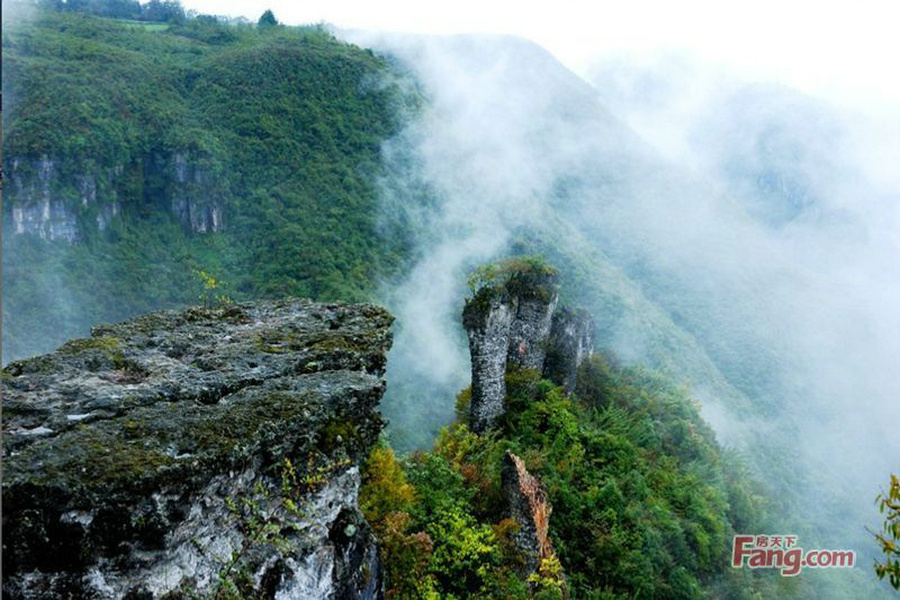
[363,355,784,599]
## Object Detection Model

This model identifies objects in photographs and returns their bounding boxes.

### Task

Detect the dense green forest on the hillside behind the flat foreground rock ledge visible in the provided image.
[3,3,405,360]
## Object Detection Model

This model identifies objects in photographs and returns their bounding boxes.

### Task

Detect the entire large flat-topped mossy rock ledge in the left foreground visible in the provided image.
[2,300,392,600]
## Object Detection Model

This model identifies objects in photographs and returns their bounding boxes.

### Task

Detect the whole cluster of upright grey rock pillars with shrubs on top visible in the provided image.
[463,264,594,433]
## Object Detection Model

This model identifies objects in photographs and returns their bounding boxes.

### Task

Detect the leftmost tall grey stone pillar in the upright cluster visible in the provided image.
[463,287,518,433]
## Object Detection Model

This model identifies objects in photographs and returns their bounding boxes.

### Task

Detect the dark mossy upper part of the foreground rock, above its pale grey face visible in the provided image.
[3,300,393,598]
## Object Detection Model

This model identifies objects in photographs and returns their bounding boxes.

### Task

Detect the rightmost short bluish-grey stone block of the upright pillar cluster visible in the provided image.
[544,308,594,394]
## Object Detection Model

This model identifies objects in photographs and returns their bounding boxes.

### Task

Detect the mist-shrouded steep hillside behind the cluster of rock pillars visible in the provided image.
[362,36,900,598]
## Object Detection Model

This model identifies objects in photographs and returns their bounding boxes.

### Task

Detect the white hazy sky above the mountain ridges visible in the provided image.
[178,0,900,108]
